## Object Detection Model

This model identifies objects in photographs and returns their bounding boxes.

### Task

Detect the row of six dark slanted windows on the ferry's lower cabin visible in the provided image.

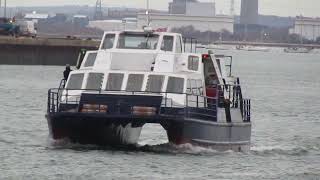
[67,73,184,93]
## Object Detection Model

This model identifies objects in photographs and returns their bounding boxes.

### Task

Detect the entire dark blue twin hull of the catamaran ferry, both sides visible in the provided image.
[47,114,251,152]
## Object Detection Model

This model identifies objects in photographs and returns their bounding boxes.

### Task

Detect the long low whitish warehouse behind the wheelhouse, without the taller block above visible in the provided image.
[138,13,234,33]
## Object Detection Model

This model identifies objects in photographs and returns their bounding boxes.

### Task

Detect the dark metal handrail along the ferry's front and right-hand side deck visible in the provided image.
[48,84,251,122]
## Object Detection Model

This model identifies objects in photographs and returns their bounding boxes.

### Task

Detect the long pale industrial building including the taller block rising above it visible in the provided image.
[137,0,234,33]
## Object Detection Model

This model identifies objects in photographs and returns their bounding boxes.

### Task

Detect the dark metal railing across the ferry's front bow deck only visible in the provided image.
[48,89,218,121]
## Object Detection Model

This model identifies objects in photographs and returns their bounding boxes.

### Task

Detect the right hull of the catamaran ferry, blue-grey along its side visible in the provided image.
[167,119,251,152]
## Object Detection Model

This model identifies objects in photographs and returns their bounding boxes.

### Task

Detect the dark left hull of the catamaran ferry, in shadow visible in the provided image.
[47,115,143,145]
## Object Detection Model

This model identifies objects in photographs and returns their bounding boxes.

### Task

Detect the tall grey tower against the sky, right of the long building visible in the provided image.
[240,0,259,24]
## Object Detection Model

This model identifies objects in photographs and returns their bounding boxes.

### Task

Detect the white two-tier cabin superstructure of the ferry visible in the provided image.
[67,28,228,106]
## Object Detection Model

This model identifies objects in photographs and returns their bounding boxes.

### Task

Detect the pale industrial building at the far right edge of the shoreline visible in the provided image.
[290,17,320,41]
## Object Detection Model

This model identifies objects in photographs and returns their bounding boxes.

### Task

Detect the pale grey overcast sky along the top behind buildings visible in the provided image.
[2,0,320,17]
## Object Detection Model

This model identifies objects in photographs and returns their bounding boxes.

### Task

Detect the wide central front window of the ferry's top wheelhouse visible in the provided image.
[117,33,159,50]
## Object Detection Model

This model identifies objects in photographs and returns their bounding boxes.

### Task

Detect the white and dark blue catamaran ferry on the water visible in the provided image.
[46,28,251,151]
